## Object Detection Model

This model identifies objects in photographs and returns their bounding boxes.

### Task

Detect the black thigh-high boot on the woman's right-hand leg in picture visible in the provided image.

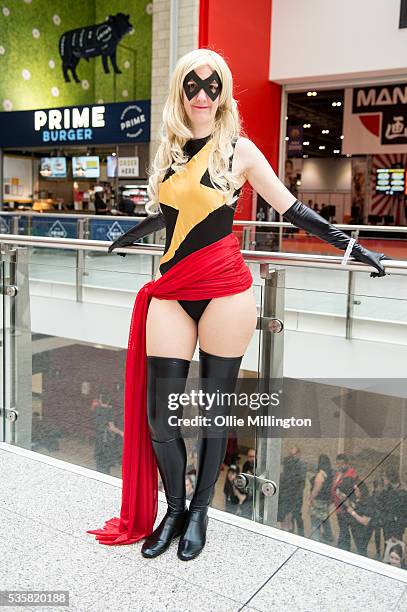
[178,348,243,561]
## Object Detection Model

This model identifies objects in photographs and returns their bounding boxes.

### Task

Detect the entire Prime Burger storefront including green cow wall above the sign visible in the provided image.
[0,0,152,225]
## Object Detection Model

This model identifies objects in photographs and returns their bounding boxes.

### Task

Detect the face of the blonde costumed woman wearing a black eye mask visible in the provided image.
[182,64,220,131]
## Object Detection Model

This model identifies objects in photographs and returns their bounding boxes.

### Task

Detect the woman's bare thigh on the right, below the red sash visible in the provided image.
[198,287,257,357]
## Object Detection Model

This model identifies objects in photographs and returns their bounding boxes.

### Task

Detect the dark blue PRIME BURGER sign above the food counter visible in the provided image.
[0,100,150,147]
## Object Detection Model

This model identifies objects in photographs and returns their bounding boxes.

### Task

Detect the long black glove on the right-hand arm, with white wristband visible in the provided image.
[283,200,391,276]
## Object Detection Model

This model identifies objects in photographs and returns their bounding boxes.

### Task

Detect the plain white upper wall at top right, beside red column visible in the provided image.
[270,0,407,83]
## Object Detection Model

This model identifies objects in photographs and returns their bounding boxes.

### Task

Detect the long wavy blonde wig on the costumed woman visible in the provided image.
[146,49,249,214]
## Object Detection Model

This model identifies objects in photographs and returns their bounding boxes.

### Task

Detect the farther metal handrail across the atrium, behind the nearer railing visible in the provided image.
[0,210,407,234]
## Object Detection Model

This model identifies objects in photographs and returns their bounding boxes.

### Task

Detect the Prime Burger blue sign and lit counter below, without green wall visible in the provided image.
[0,100,150,214]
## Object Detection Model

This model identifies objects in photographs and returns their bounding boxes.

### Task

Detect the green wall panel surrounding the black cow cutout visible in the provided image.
[0,0,152,111]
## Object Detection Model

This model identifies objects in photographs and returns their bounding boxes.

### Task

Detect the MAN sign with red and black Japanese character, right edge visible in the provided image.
[342,83,407,154]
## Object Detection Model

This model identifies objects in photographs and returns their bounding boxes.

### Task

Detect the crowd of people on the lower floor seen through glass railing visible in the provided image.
[87,393,407,569]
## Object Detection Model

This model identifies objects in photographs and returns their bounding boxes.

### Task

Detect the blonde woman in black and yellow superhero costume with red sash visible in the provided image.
[90,49,385,560]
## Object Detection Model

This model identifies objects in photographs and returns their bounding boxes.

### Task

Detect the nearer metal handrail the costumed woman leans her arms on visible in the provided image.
[0,234,407,275]
